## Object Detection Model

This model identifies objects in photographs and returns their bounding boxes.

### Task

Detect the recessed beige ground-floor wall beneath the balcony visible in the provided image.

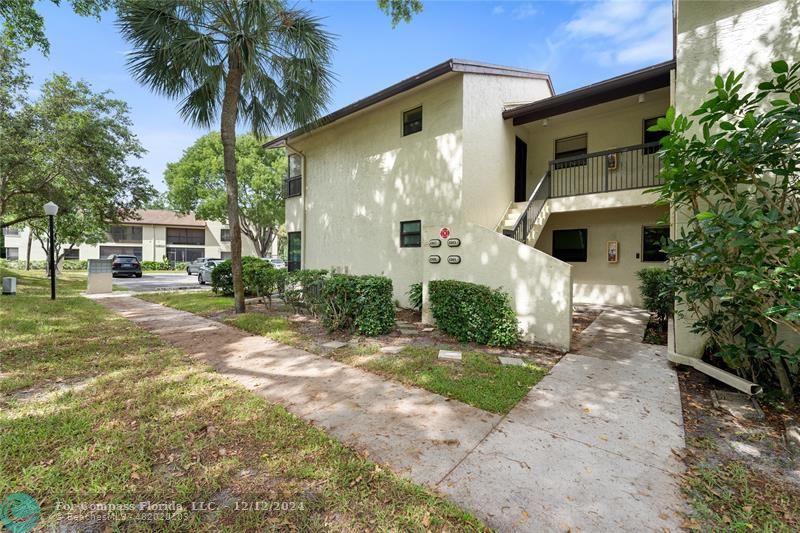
[536,206,668,305]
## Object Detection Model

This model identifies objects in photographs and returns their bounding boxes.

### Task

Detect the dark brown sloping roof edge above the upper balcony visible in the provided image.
[503,59,675,126]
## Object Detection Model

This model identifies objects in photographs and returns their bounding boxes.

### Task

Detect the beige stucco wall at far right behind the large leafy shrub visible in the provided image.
[669,0,800,356]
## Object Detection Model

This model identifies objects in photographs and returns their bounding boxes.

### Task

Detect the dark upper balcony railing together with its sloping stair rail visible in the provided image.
[503,142,661,242]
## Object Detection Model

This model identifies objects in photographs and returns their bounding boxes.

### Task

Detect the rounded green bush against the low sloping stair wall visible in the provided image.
[428,280,520,346]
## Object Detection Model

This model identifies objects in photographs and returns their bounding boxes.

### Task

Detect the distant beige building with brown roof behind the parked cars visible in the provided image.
[4,209,277,261]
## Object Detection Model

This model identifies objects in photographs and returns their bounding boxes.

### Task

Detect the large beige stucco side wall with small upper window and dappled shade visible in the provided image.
[287,75,466,304]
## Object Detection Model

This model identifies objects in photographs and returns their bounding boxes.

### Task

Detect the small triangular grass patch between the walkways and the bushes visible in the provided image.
[333,346,547,414]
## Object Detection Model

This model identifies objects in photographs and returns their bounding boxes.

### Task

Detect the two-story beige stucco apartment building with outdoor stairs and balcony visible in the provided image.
[267,0,798,354]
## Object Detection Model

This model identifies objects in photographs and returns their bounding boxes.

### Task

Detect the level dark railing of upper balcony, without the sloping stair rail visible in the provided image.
[550,142,661,198]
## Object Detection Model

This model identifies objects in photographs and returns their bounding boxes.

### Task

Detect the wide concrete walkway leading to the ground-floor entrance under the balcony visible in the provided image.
[440,308,684,531]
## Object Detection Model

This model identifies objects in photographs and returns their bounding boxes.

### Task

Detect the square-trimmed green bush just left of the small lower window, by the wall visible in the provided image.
[322,274,394,337]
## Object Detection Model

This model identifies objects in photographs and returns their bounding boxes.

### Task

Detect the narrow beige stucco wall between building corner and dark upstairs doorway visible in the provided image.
[463,74,551,228]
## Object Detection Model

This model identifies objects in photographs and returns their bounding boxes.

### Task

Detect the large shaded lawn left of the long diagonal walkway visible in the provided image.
[0,271,484,531]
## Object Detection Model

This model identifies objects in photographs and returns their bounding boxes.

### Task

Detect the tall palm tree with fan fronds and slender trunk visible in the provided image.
[118,0,334,313]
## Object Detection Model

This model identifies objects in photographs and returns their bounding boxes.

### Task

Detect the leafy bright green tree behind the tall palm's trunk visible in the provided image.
[164,133,286,257]
